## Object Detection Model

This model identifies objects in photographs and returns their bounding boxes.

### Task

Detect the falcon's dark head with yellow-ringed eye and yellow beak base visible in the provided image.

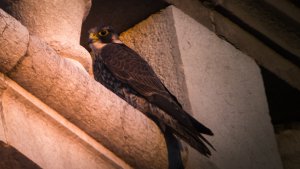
[89,26,120,44]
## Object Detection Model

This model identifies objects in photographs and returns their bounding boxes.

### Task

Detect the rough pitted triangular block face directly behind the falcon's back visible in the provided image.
[120,10,190,112]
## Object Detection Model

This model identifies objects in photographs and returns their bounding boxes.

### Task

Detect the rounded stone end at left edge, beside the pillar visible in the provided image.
[0,9,29,73]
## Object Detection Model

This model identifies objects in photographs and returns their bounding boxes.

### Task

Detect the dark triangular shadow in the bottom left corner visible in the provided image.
[0,141,41,169]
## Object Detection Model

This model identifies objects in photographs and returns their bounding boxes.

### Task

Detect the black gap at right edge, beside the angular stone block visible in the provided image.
[260,67,300,125]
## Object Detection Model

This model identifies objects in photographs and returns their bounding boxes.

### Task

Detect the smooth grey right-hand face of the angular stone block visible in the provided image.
[169,5,282,169]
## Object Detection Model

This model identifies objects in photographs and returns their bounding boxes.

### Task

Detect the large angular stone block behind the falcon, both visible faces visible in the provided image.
[121,6,282,169]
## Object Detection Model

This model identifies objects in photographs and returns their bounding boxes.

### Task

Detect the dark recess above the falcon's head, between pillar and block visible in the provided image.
[80,0,168,50]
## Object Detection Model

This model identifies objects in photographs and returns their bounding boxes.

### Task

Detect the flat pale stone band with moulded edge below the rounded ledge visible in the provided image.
[1,79,129,169]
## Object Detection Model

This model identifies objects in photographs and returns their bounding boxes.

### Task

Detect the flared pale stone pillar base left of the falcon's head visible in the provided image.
[5,0,92,72]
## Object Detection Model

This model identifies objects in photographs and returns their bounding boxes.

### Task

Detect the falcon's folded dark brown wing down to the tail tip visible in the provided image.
[101,43,213,155]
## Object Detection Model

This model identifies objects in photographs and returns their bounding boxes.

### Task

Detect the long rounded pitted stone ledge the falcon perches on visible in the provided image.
[9,37,167,168]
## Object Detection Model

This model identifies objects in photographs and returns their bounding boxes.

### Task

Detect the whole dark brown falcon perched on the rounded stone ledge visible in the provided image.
[89,26,214,156]
